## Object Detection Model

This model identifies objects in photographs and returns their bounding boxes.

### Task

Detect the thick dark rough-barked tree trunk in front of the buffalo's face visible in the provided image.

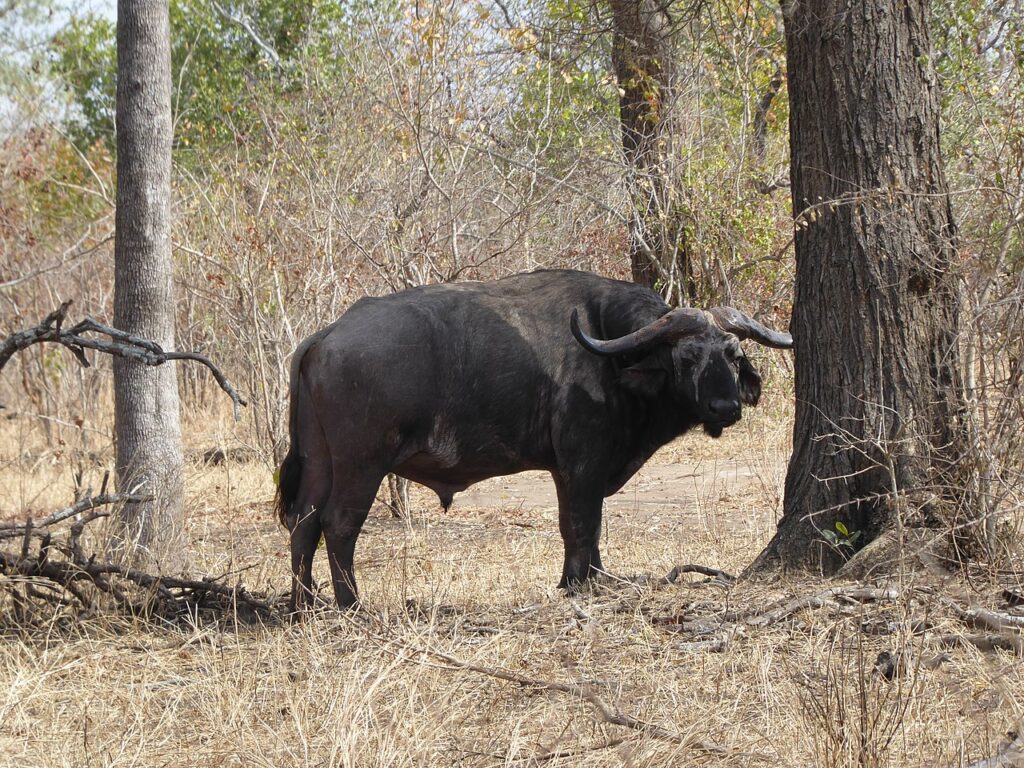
[752,0,964,572]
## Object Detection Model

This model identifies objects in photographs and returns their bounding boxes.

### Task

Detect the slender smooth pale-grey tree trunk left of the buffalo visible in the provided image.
[114,0,182,565]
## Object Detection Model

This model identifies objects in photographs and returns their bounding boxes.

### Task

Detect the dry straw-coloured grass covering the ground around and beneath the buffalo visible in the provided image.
[0,399,1024,767]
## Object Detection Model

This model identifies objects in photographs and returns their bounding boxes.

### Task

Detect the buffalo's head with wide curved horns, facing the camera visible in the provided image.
[569,306,793,437]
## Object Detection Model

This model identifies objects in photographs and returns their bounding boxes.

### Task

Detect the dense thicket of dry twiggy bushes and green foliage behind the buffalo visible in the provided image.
[0,0,1024,573]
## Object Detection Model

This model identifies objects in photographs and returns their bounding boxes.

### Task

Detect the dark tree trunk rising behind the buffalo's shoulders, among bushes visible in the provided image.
[610,0,694,304]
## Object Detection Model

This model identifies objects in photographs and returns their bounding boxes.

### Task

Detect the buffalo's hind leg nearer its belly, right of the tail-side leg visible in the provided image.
[321,473,384,608]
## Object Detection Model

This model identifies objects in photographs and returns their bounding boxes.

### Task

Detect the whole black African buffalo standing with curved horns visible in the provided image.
[278,270,793,611]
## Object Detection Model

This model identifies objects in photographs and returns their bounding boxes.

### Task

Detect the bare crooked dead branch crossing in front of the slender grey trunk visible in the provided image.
[0,300,247,421]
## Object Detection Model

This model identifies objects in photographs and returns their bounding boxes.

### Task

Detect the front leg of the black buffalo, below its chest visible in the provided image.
[555,476,604,592]
